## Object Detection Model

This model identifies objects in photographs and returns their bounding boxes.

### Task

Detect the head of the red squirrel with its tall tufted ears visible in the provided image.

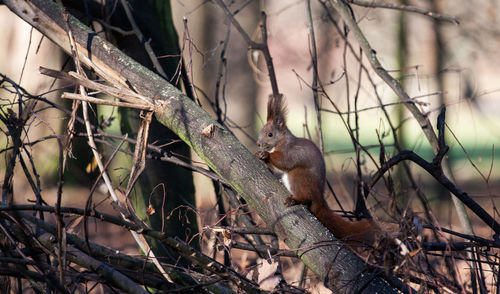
[257,94,287,152]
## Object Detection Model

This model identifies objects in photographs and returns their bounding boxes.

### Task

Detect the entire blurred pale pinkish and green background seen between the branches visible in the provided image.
[0,0,500,292]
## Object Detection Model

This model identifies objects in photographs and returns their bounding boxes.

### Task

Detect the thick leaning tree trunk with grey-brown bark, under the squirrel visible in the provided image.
[4,0,397,293]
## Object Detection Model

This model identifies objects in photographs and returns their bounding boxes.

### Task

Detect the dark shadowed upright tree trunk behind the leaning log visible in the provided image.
[66,0,198,257]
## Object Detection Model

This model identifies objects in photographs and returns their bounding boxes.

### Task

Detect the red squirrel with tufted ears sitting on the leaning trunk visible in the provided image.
[256,95,382,249]
